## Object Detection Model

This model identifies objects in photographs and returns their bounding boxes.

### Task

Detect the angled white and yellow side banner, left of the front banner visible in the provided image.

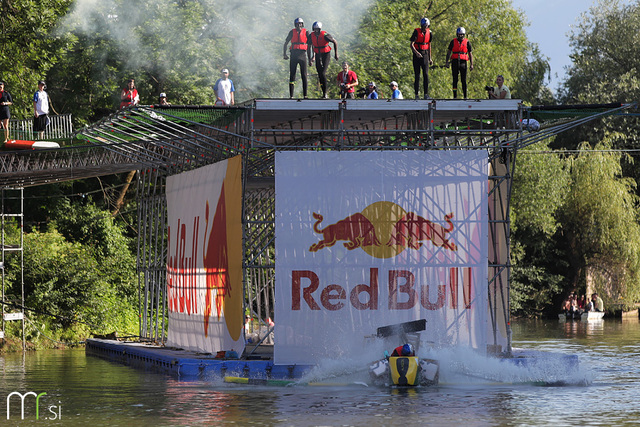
[166,156,244,354]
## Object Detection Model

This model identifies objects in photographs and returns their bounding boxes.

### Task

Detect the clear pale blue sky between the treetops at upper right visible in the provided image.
[512,0,632,92]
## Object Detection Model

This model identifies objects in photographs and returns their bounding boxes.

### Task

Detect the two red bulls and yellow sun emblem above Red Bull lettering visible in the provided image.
[309,202,458,258]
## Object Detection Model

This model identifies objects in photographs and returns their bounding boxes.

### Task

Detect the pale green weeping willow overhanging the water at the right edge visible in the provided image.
[562,142,640,303]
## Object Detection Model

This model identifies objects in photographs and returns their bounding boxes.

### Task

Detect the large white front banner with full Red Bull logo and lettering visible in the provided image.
[275,150,488,364]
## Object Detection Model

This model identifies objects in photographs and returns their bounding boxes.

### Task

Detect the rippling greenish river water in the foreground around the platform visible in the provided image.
[0,319,640,427]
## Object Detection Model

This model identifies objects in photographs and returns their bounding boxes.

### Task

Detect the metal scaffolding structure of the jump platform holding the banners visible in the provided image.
[0,99,633,350]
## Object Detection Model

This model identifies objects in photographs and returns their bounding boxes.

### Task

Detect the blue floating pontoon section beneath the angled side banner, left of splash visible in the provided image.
[85,338,312,381]
